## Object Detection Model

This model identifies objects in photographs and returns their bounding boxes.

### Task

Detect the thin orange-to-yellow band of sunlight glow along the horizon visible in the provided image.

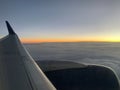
[21,38,120,43]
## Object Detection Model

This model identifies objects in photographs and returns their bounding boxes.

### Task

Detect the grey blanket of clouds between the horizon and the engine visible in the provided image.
[24,42,120,78]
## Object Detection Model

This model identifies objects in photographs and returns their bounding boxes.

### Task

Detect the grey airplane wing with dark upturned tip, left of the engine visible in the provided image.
[0,21,56,90]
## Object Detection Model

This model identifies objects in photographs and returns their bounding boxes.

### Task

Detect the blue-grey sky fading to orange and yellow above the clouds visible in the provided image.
[0,0,120,43]
